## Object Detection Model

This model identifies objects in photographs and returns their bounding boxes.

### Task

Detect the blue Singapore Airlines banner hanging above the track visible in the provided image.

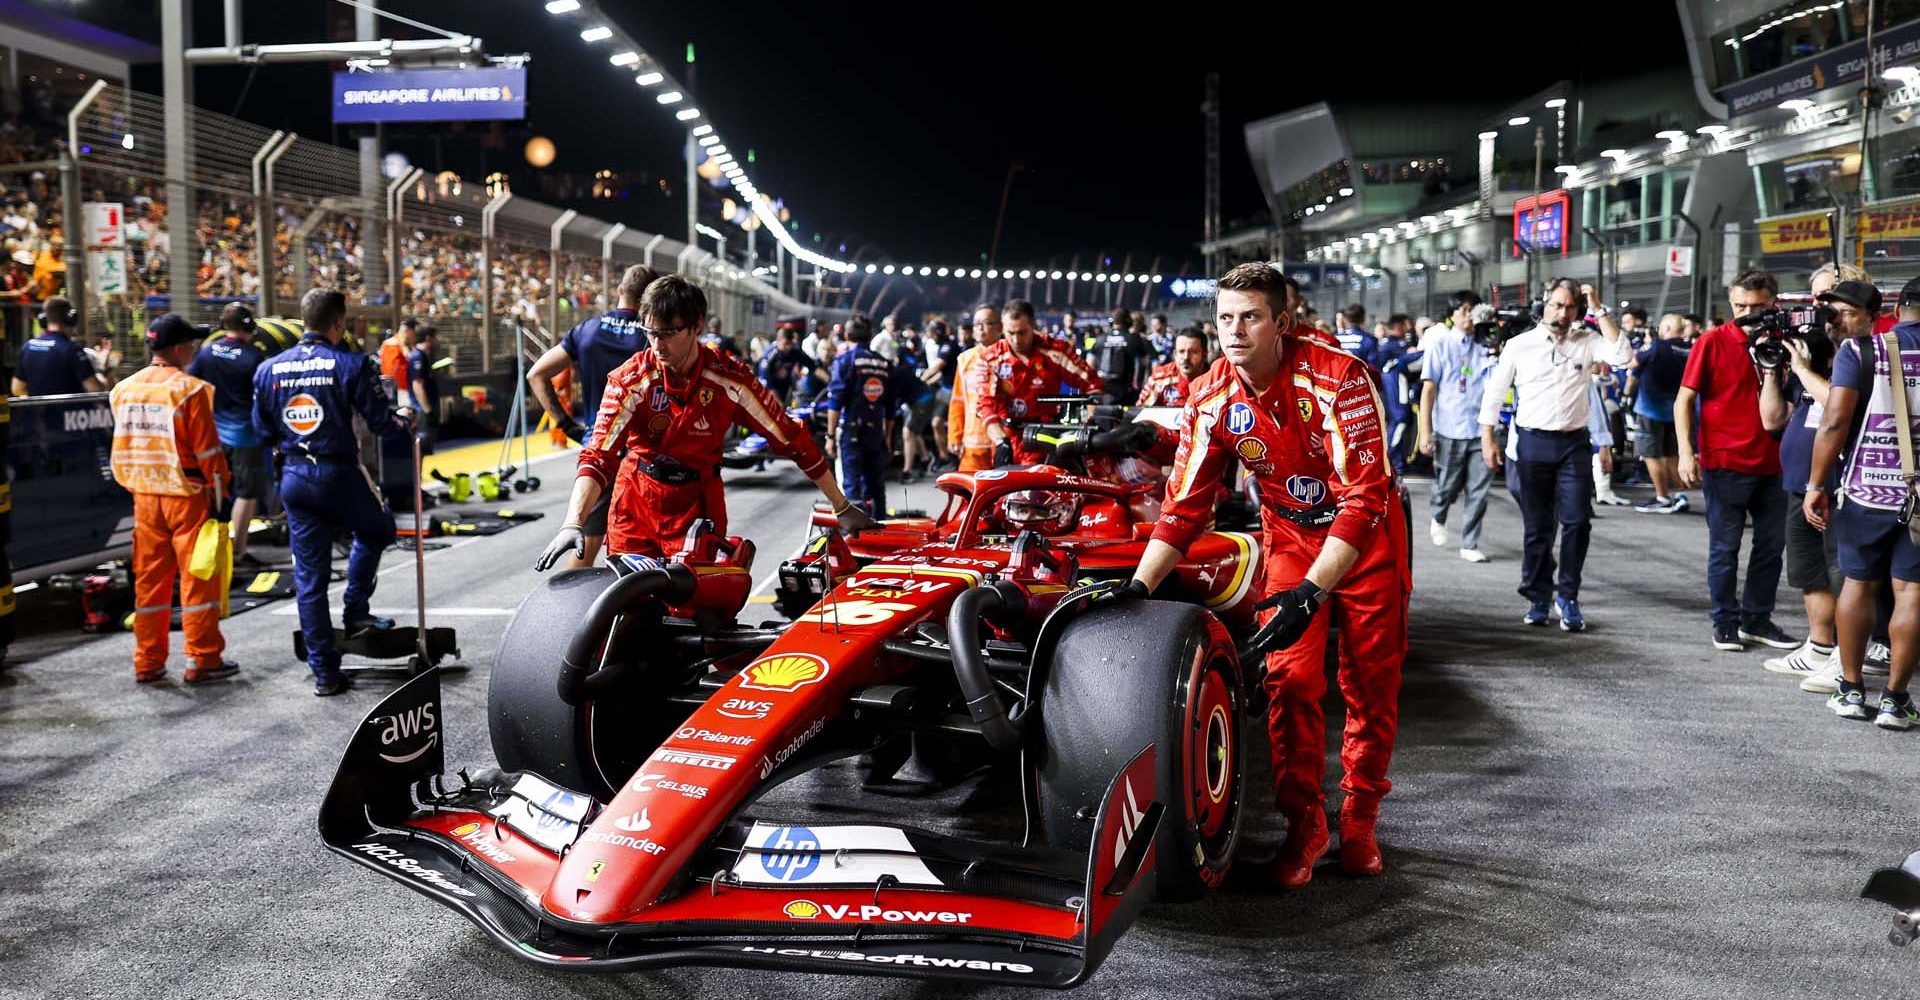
[334,67,526,125]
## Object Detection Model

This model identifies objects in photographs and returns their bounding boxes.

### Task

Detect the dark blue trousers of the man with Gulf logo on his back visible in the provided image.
[280,457,394,679]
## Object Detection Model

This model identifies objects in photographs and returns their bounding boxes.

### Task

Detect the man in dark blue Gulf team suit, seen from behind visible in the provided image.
[253,288,413,697]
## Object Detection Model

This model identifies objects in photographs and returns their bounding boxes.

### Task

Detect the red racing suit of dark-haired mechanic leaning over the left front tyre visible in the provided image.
[580,345,828,559]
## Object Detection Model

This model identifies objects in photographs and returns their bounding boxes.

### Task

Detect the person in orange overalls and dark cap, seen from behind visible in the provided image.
[113,313,240,683]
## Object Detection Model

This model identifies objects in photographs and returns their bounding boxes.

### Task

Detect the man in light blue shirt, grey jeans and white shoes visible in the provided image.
[1419,292,1500,562]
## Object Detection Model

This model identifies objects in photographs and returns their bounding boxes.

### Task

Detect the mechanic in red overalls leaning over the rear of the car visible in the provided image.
[966,299,1100,464]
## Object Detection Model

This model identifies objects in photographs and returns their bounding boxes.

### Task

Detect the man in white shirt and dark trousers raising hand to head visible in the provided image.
[1480,278,1632,631]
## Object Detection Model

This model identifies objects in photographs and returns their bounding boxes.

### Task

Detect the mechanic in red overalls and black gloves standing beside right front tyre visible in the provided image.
[1127,263,1411,889]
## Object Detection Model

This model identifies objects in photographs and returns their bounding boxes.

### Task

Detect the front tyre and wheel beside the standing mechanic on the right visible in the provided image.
[1029,601,1246,902]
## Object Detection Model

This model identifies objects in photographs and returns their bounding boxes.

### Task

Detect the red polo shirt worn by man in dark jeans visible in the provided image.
[1680,322,1780,476]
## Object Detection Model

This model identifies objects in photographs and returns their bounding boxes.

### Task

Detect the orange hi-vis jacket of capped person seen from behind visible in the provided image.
[111,365,232,497]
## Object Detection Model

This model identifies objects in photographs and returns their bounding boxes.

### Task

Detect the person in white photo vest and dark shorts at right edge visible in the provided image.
[1803,280,1920,729]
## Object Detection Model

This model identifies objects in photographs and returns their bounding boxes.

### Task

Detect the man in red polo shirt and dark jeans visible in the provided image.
[1674,271,1801,651]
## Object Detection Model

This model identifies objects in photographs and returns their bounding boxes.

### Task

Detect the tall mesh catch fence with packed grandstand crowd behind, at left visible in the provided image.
[61,83,825,372]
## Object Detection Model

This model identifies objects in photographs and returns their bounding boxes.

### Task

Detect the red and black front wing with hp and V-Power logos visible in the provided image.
[321,672,1164,987]
